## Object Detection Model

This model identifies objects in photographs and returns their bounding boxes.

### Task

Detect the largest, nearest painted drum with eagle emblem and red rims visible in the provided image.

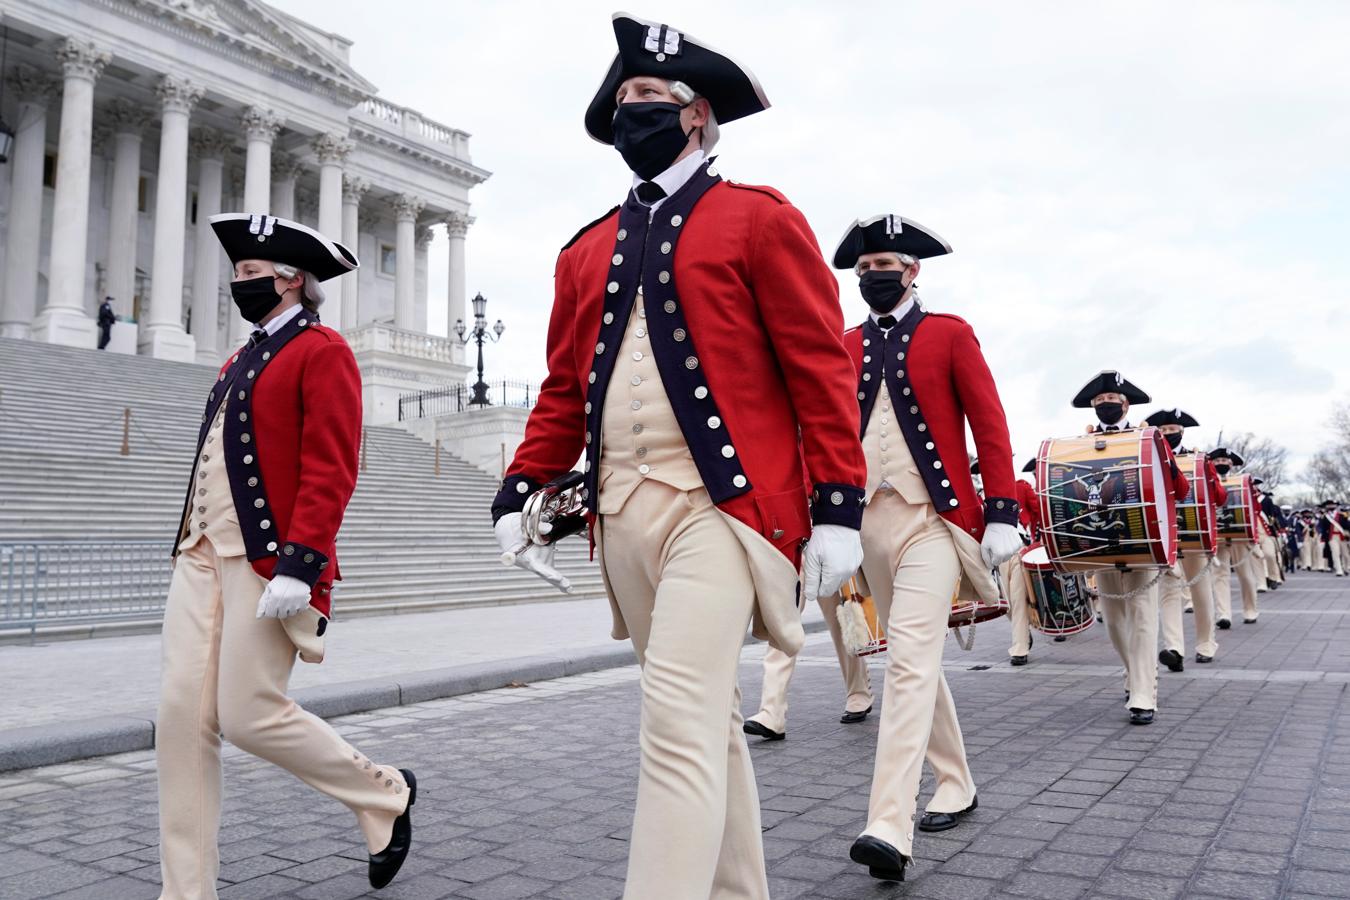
[1035,428,1177,572]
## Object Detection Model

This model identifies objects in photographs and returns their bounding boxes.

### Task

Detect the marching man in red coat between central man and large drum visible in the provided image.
[834,215,1022,881]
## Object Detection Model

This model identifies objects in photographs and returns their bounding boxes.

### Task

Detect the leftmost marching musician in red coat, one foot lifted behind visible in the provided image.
[155,213,417,900]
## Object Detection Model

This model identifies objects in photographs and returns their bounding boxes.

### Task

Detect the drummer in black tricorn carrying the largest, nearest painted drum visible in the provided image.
[1073,368,1191,725]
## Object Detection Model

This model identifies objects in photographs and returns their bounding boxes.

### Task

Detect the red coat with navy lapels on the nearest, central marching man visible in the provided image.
[493,166,867,561]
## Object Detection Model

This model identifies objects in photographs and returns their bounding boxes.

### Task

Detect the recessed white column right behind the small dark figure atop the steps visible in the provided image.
[107,97,150,317]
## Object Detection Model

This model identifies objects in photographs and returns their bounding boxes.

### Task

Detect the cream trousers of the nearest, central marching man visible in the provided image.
[599,480,768,900]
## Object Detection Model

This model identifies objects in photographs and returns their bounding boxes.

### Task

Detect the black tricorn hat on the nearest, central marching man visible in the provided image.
[586,12,768,144]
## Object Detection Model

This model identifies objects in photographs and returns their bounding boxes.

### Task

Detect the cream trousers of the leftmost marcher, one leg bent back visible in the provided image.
[155,541,408,900]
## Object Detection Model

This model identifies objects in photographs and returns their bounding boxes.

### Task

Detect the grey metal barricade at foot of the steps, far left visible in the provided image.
[0,541,171,634]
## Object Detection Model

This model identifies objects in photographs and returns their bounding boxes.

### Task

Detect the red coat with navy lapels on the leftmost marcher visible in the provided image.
[174,312,362,615]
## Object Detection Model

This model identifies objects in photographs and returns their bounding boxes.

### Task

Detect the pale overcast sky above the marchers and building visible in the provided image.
[274,0,1350,493]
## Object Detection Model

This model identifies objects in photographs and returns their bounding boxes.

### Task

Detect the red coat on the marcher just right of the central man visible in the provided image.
[844,304,1018,540]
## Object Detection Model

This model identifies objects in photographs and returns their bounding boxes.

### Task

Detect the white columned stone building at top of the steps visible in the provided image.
[0,0,489,421]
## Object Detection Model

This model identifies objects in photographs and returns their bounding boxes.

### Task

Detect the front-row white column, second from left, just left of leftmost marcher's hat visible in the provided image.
[136,76,201,363]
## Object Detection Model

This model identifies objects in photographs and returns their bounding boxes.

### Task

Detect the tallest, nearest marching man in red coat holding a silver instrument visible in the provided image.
[493,13,867,900]
